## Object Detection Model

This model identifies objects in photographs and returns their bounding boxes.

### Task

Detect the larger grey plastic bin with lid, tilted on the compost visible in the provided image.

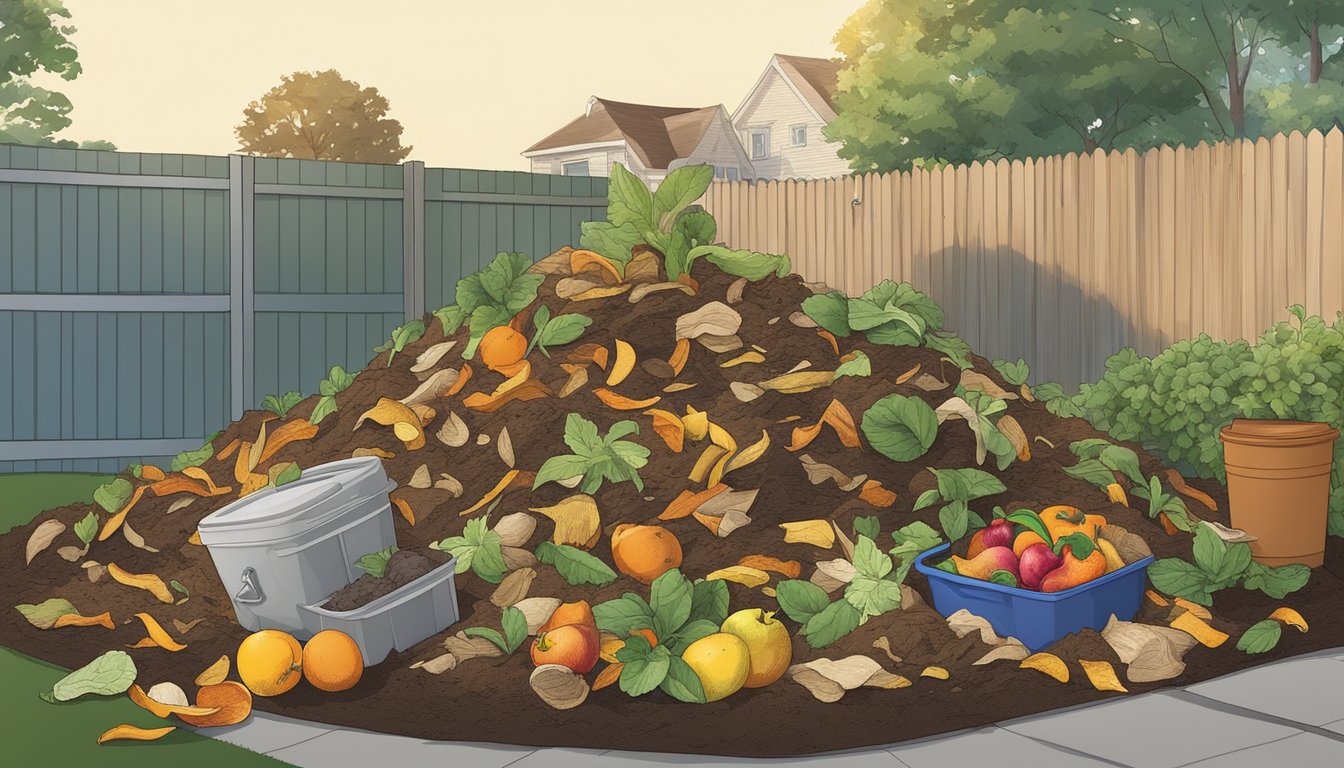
[199,456,397,639]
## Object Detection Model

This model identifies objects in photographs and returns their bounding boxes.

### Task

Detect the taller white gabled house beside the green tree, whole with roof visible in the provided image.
[732,54,851,179]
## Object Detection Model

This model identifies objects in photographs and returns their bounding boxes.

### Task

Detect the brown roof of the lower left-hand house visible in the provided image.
[524,95,722,169]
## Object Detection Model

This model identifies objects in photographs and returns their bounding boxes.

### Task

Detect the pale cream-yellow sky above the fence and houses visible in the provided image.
[40,0,862,169]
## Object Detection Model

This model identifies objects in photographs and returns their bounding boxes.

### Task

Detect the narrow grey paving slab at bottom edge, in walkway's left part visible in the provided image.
[269,730,536,768]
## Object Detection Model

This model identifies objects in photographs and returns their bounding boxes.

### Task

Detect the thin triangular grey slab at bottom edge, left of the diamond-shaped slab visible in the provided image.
[887,726,1113,768]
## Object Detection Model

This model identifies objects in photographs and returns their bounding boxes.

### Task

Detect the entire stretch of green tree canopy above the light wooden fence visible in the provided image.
[827,0,1344,171]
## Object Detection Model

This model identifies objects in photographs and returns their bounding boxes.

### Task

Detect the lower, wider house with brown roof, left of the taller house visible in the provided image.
[523,95,754,188]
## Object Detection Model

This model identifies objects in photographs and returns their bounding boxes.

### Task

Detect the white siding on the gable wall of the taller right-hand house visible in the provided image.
[734,67,849,179]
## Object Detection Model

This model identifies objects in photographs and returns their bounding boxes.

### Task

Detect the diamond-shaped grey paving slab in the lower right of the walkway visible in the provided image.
[1001,693,1301,768]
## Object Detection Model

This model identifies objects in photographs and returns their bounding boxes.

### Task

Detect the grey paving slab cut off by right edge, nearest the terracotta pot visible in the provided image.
[1185,658,1344,725]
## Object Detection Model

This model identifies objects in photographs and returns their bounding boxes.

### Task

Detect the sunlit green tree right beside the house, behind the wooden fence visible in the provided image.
[827,0,1199,171]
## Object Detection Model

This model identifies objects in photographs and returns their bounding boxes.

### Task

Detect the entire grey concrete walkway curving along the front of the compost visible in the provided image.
[196,648,1344,768]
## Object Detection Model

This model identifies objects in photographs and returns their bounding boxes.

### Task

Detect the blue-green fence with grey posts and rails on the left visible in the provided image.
[0,145,606,472]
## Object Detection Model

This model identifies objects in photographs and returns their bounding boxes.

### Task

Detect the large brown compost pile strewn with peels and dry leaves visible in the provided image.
[0,242,1344,757]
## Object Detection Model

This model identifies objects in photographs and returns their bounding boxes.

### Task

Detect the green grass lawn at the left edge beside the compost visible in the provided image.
[0,473,284,768]
